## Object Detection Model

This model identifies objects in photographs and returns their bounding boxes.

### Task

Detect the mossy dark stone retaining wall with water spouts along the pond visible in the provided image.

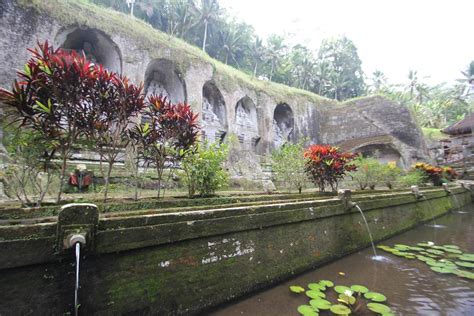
[0,188,471,315]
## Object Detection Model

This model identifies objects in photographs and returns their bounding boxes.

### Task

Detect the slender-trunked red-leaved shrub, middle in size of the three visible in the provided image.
[131,95,199,198]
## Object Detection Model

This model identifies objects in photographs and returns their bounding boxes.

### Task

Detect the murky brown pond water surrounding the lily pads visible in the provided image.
[211,205,474,316]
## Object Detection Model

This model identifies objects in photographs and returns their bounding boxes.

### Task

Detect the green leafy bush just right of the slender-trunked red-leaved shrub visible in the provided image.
[181,143,229,197]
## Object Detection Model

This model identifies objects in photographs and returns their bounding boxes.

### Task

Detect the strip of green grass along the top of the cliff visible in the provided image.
[17,0,336,105]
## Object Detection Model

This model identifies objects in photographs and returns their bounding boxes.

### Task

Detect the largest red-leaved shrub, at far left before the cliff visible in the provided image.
[0,42,143,202]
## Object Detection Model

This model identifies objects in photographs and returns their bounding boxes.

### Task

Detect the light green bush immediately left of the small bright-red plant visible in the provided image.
[272,142,308,193]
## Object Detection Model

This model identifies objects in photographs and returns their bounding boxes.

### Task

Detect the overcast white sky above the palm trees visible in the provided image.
[219,0,474,84]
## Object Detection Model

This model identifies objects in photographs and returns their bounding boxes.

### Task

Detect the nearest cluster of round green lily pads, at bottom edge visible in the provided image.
[290,280,393,316]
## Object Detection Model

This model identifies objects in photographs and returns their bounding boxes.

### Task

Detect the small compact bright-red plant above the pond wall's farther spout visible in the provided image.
[304,145,357,192]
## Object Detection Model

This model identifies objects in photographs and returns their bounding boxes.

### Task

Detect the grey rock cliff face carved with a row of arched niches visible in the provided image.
[0,0,426,178]
